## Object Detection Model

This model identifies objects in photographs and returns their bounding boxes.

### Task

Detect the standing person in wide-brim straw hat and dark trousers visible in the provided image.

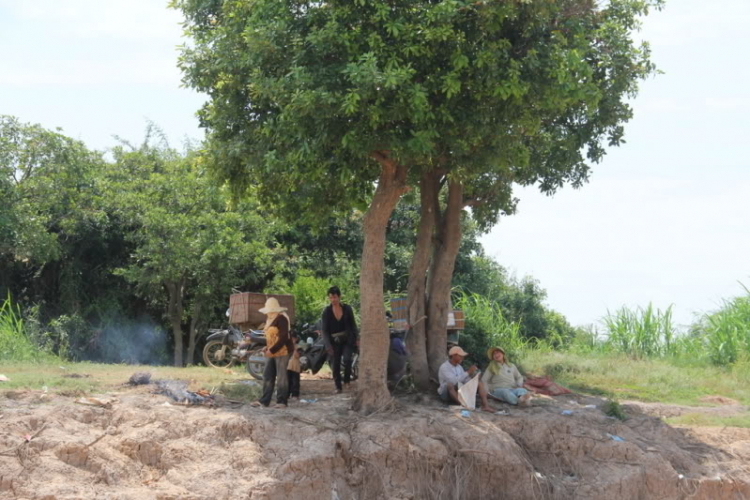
[253,297,294,408]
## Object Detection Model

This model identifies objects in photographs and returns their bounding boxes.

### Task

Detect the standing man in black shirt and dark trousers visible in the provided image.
[322,286,357,392]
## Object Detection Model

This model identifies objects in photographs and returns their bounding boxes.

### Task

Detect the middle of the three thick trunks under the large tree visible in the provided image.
[406,170,442,391]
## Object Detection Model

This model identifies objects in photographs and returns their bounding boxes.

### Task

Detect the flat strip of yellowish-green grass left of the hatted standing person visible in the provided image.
[0,360,250,395]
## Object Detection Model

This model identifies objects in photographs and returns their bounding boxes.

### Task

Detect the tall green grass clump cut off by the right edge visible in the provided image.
[693,285,750,365]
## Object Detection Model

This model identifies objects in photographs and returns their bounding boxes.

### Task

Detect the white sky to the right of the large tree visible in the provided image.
[483,0,750,324]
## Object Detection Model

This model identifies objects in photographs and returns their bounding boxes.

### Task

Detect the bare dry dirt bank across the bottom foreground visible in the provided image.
[0,383,750,500]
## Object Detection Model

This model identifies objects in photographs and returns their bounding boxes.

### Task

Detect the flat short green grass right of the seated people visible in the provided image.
[523,351,750,406]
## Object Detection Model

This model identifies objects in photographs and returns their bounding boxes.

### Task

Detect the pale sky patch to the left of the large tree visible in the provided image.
[0,0,205,149]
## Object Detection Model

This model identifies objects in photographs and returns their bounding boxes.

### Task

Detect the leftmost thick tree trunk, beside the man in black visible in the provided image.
[354,152,407,414]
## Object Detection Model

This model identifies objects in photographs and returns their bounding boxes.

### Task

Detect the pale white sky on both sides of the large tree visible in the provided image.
[0,0,750,324]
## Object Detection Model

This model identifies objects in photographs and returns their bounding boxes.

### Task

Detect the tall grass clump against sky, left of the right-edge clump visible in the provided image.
[602,304,677,358]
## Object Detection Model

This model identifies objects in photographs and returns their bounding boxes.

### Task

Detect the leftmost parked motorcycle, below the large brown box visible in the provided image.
[203,325,266,380]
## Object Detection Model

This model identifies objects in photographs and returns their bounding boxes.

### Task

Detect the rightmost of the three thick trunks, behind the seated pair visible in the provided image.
[427,180,463,378]
